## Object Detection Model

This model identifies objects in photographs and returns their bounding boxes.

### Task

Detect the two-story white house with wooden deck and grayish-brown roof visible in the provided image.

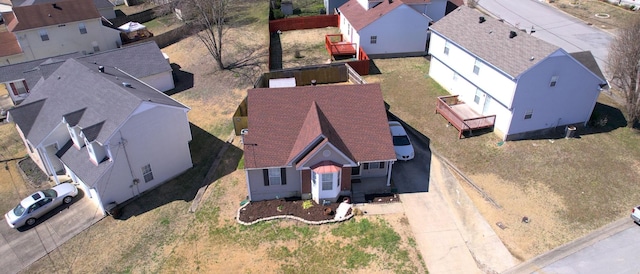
[429,7,608,140]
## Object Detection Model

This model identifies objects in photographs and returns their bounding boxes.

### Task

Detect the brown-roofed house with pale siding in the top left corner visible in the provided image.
[0,0,122,66]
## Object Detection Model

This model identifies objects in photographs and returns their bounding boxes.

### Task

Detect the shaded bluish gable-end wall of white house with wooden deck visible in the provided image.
[508,54,601,134]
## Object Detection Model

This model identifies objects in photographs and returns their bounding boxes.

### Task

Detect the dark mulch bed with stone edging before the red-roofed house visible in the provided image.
[239,198,351,222]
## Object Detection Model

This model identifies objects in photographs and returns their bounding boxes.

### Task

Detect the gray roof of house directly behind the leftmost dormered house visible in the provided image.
[0,41,171,88]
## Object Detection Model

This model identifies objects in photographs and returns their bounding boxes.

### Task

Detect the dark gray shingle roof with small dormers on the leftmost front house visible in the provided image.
[9,59,187,145]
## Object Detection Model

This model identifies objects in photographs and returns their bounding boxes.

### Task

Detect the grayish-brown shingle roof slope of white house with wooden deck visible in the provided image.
[431,6,560,78]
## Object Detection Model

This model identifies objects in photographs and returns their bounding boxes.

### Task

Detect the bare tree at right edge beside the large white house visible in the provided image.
[607,16,640,128]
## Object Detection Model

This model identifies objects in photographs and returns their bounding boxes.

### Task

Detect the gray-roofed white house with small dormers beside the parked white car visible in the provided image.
[8,59,192,216]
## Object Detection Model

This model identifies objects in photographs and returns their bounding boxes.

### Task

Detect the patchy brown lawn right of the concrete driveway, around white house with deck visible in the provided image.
[365,58,640,259]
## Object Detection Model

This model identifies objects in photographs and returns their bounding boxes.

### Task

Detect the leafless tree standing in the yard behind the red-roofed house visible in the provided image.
[180,0,230,69]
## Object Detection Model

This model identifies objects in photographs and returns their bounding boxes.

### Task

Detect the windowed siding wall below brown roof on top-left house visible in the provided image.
[15,19,121,61]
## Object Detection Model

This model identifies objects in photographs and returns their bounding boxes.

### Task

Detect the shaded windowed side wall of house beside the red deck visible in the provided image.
[358,5,429,54]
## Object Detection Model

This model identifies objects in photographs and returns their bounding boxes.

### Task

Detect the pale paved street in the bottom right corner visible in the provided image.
[506,218,640,274]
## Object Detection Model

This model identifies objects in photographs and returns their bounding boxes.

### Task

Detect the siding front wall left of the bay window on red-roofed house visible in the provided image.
[246,167,302,201]
